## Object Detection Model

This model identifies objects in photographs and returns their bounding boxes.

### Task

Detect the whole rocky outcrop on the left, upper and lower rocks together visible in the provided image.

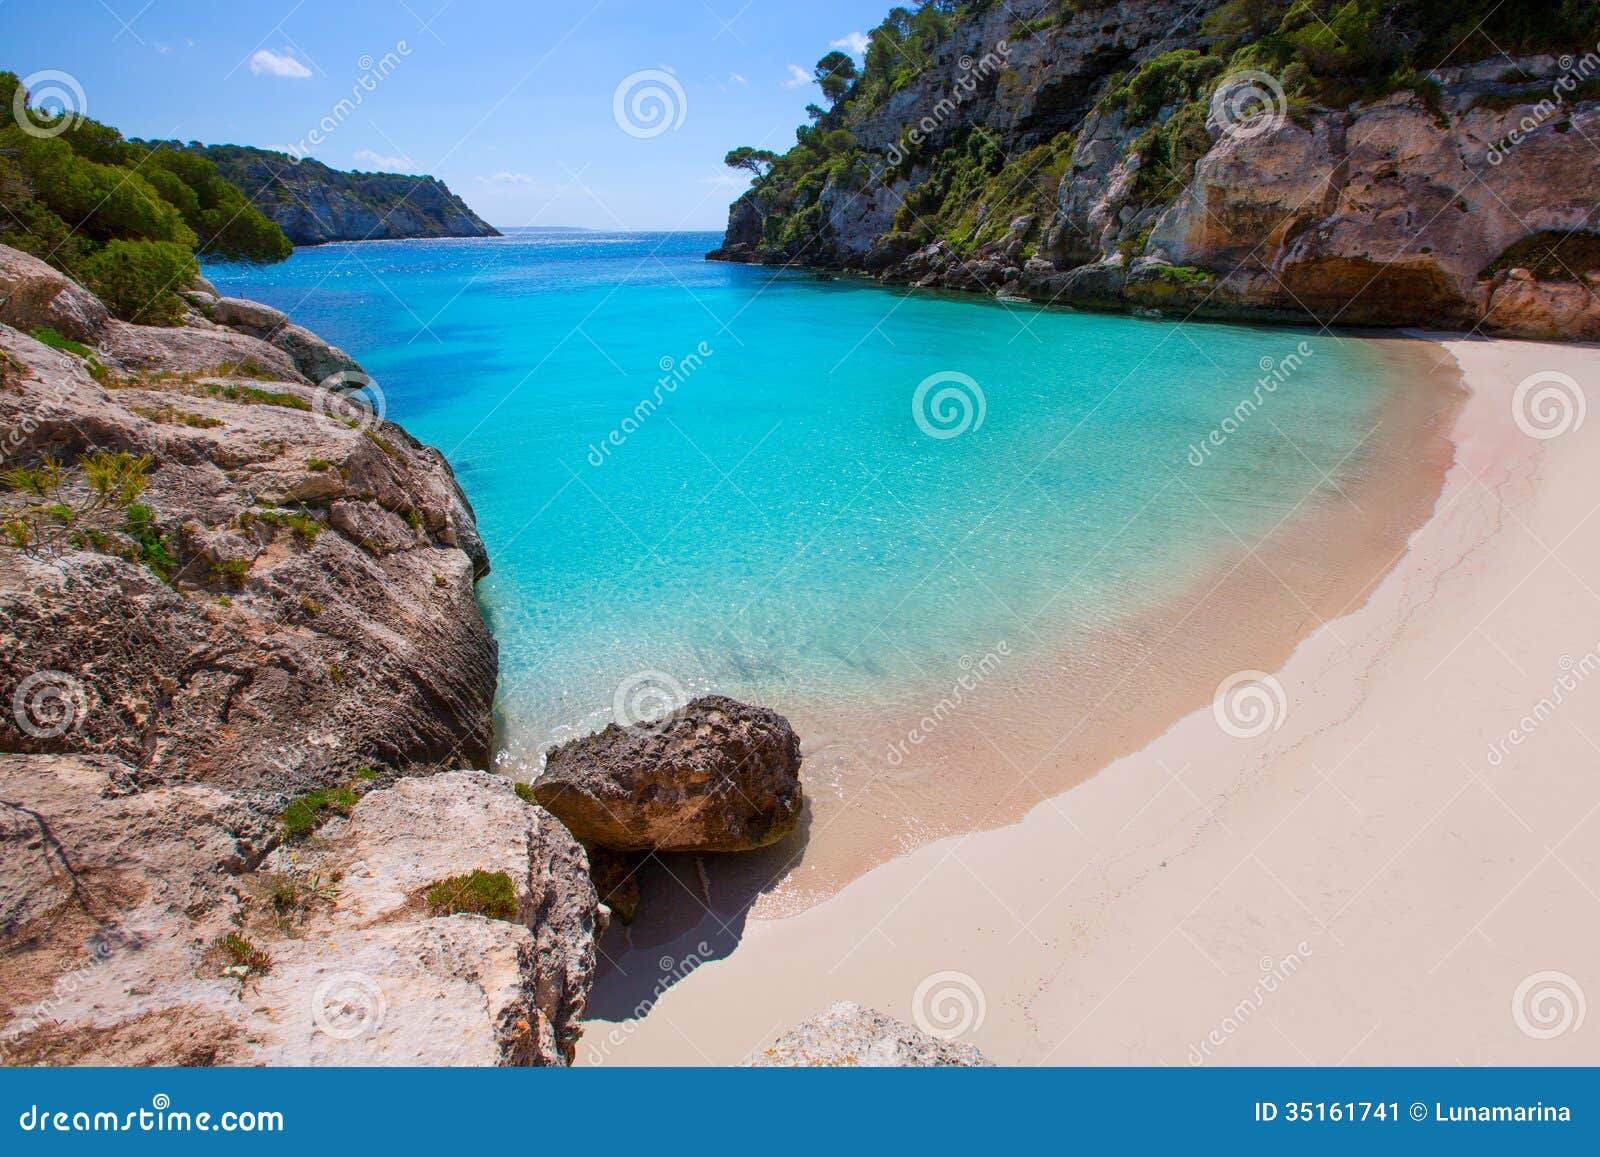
[0,246,605,1064]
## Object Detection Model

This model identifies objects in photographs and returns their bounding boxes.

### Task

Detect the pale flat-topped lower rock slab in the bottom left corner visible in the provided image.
[0,768,603,1064]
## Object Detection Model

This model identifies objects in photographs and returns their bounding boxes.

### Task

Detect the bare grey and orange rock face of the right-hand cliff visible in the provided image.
[715,0,1600,339]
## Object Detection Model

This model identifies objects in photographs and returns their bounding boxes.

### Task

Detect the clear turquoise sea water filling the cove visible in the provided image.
[208,230,1389,759]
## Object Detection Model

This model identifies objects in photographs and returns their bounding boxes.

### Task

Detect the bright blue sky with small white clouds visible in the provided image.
[0,0,891,229]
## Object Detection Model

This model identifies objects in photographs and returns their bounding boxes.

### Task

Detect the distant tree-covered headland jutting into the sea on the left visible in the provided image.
[150,142,499,245]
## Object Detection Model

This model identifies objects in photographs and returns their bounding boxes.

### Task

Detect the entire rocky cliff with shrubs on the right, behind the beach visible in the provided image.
[710,0,1600,339]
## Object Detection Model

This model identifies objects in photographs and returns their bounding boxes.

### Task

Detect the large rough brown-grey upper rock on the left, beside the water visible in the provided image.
[0,326,496,797]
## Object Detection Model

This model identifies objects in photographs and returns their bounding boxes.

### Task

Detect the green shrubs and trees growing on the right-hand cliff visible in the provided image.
[728,0,1600,262]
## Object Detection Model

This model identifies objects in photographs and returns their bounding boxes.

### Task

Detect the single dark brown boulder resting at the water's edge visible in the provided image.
[533,695,802,851]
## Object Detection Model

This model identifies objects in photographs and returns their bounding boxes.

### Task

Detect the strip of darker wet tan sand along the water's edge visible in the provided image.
[602,334,1464,947]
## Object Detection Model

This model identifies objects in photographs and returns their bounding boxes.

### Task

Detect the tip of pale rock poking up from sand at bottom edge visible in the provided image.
[747,1000,989,1069]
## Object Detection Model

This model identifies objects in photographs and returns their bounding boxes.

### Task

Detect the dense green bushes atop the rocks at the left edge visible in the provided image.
[0,72,293,325]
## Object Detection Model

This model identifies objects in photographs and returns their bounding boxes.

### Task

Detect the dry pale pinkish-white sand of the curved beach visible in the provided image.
[578,338,1600,1064]
